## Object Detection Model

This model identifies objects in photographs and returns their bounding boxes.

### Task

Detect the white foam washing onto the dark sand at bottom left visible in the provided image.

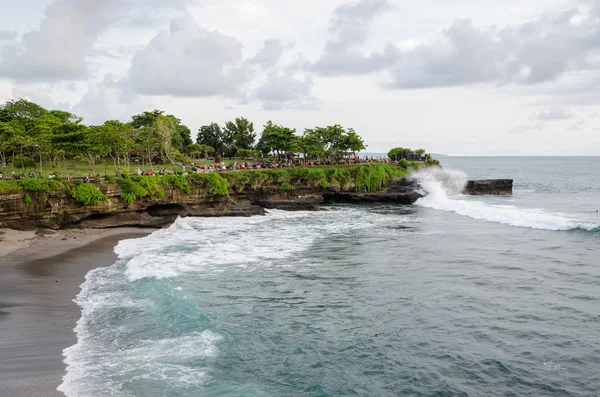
[57,264,222,397]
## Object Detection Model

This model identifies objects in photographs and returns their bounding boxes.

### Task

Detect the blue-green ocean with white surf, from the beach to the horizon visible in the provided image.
[59,157,600,397]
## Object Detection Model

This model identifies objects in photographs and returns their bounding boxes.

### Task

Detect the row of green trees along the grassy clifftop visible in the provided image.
[0,99,380,174]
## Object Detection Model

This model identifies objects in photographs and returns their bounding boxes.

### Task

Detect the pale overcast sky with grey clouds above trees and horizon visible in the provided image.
[0,0,600,156]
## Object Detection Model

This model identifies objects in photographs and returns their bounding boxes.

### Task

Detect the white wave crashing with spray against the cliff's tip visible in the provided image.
[413,169,600,232]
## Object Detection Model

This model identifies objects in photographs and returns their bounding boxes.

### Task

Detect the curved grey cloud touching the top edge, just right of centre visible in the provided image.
[308,0,399,76]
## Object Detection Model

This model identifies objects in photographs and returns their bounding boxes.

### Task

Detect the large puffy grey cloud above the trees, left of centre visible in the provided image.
[124,14,249,97]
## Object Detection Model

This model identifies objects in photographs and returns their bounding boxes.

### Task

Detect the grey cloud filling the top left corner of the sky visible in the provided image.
[0,0,116,82]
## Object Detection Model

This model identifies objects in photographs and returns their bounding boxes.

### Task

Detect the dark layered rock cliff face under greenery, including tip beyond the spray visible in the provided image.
[0,178,512,229]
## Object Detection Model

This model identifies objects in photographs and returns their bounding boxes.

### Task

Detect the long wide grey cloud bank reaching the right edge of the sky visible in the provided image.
[387,4,600,89]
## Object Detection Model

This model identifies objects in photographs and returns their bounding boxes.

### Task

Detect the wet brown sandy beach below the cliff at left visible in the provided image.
[0,228,153,397]
